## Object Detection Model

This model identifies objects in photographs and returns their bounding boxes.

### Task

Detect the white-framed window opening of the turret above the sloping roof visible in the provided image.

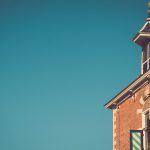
[142,42,150,73]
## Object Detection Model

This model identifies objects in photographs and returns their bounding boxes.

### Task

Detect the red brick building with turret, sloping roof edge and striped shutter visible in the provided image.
[105,4,150,150]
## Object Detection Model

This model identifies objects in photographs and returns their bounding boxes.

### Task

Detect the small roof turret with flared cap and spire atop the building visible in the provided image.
[133,2,150,74]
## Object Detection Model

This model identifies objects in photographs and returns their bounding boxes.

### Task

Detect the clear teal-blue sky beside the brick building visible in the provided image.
[0,0,147,150]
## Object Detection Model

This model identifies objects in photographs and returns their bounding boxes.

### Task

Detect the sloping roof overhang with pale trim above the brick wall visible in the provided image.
[104,70,150,109]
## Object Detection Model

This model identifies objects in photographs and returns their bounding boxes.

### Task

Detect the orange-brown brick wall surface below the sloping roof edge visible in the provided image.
[114,85,149,150]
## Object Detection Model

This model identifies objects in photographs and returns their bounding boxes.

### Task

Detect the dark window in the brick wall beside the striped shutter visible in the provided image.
[145,112,150,150]
